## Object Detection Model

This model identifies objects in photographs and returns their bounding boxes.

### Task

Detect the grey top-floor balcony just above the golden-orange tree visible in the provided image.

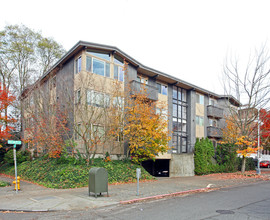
[130,80,158,101]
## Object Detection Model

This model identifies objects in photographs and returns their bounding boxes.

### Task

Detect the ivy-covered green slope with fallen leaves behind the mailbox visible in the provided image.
[0,158,154,189]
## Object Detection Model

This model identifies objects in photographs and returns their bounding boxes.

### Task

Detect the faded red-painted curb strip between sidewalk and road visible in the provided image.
[119,187,213,205]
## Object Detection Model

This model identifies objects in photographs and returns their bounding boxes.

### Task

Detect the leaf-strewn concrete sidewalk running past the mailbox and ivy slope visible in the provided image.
[0,173,270,211]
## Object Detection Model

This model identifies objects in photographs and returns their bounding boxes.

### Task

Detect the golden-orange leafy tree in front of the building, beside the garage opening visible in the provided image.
[124,85,170,163]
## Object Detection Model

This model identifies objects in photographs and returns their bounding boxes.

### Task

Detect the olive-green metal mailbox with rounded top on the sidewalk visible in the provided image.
[88,167,109,198]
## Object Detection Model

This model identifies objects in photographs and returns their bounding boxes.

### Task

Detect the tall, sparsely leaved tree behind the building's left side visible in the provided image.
[0,25,64,133]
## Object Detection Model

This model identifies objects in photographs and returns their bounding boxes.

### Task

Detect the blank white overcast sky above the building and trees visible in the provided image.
[0,0,270,94]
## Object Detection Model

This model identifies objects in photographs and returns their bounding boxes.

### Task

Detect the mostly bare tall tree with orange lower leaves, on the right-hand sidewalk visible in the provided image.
[223,47,270,172]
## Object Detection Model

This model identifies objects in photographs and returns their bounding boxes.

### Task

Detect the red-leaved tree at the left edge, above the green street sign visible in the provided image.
[0,84,15,141]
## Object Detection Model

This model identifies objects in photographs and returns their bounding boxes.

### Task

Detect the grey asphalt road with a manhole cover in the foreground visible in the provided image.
[0,182,270,220]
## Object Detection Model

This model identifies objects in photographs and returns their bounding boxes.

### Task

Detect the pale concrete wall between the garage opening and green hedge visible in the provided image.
[170,153,194,177]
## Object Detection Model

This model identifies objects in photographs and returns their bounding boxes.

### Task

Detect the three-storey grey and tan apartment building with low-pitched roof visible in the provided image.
[22,41,240,176]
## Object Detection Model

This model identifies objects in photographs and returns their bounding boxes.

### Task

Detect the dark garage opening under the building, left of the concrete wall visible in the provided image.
[142,159,170,177]
